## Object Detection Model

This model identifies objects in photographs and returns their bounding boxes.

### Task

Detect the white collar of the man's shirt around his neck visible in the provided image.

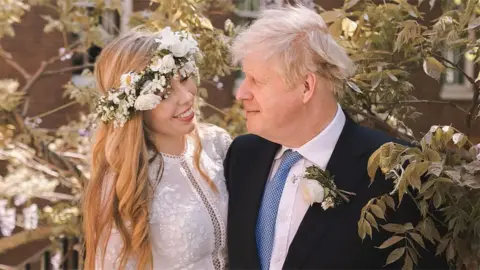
[275,104,346,169]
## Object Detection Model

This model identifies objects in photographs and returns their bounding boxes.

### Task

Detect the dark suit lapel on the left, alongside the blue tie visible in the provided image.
[238,137,280,269]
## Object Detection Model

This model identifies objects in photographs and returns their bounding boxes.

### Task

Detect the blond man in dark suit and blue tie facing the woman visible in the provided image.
[224,6,446,269]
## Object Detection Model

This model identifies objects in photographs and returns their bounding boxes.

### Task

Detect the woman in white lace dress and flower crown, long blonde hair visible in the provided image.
[83,25,231,270]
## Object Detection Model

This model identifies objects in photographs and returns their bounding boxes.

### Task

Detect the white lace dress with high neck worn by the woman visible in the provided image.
[96,126,231,270]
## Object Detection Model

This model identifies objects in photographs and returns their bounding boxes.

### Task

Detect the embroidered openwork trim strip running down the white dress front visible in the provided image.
[181,160,226,269]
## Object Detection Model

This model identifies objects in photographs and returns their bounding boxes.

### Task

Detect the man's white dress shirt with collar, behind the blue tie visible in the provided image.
[269,105,345,270]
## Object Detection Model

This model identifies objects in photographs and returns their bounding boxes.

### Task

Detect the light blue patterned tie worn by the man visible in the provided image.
[255,150,302,270]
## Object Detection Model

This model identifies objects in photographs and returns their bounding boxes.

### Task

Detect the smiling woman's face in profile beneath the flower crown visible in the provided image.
[145,77,197,137]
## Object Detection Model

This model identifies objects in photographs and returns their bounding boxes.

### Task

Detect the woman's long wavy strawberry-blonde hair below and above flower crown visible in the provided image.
[82,29,216,269]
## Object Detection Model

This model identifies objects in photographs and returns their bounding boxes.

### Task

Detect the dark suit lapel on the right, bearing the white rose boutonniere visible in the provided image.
[284,116,365,269]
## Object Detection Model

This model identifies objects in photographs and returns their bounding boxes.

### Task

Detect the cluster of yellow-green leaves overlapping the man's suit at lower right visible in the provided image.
[359,126,480,269]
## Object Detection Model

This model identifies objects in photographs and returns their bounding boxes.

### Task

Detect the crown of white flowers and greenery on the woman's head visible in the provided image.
[96,27,200,128]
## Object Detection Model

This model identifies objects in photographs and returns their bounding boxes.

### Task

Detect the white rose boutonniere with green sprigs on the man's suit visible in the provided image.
[302,166,355,210]
